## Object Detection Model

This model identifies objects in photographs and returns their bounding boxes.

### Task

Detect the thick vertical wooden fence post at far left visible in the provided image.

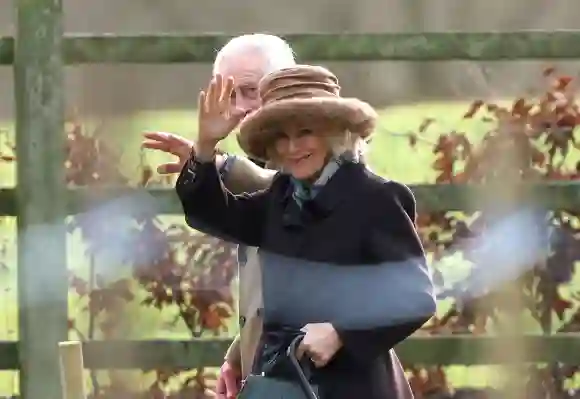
[14,0,67,399]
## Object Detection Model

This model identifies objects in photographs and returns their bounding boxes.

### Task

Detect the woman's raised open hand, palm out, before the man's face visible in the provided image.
[196,74,245,156]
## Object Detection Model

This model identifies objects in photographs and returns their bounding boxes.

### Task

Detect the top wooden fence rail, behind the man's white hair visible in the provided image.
[0,31,580,65]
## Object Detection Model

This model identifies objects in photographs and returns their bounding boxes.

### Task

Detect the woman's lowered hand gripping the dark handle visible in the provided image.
[297,323,342,368]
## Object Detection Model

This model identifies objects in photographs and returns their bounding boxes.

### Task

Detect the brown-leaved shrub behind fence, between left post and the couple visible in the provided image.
[66,120,237,399]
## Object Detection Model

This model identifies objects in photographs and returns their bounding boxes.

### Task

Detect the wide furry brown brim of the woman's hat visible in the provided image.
[237,97,377,161]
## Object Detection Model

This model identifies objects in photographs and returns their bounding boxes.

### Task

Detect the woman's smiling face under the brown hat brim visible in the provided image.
[274,121,338,180]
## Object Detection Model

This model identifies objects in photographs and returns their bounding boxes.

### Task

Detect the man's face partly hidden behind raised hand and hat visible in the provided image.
[217,52,266,114]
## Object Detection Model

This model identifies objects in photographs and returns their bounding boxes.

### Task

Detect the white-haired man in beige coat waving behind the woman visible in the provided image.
[143,34,295,399]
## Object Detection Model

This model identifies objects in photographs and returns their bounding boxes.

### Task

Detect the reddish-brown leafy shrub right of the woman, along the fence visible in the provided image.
[407,68,580,398]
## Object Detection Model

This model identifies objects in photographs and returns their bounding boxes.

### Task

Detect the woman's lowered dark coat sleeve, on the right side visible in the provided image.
[337,182,436,362]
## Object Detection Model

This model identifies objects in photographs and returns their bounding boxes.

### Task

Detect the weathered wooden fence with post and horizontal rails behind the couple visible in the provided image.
[0,0,580,399]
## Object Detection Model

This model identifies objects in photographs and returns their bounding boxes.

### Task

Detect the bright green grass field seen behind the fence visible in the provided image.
[0,103,568,395]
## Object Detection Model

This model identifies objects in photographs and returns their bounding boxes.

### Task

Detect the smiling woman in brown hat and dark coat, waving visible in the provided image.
[176,65,435,399]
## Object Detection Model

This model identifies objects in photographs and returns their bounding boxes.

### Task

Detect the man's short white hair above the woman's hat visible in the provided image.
[213,33,296,75]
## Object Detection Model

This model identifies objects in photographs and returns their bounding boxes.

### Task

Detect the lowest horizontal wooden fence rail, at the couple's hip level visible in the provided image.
[0,334,580,370]
